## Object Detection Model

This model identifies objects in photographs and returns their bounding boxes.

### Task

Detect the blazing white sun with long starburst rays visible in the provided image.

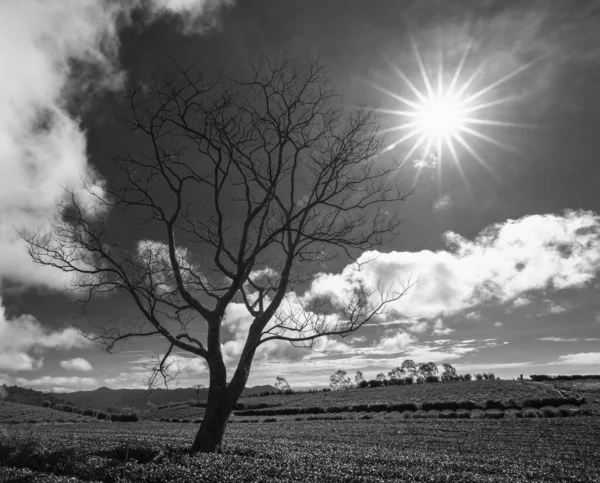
[372,41,535,184]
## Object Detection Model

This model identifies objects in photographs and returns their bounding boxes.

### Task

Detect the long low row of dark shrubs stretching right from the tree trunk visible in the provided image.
[235,397,586,416]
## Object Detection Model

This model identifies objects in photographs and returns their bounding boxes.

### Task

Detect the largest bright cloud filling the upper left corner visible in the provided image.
[0,0,232,289]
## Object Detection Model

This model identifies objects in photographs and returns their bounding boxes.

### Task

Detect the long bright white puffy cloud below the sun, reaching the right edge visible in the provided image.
[310,211,600,318]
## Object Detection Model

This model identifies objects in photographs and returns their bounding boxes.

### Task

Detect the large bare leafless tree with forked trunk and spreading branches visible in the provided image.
[22,56,408,452]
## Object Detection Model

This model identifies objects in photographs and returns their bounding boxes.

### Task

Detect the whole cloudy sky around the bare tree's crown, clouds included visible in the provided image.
[0,0,600,391]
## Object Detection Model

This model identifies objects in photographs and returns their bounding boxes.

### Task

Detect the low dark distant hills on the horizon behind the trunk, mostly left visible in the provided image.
[4,385,275,411]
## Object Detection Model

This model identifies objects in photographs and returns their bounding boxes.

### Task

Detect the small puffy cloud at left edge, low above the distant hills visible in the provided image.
[0,299,90,371]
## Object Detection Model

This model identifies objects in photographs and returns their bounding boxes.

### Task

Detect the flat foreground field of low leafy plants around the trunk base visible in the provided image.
[0,417,600,483]
